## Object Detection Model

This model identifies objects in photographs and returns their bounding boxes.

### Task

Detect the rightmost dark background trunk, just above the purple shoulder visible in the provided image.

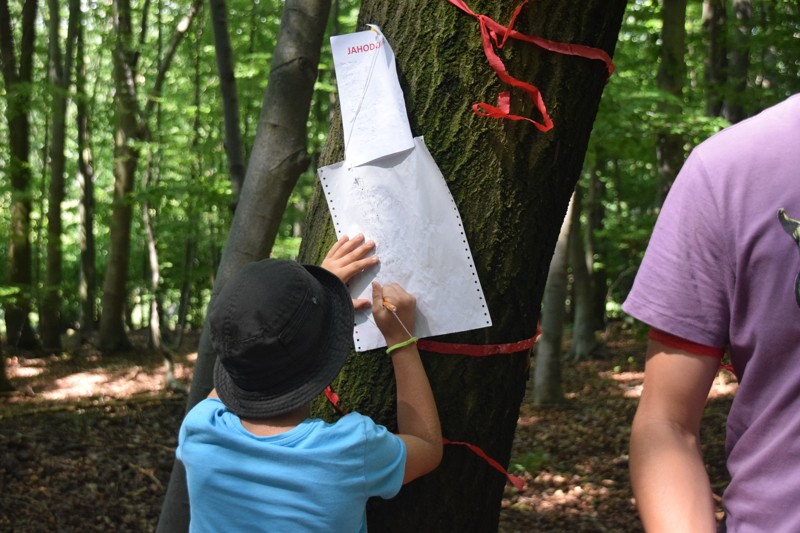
[723,0,753,124]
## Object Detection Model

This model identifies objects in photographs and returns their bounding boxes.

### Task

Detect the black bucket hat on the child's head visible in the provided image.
[208,259,354,419]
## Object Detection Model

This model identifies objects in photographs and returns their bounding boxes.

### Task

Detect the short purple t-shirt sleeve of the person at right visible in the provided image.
[622,150,733,348]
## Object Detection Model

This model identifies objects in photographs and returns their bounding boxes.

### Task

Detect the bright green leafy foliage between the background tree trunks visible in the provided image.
[0,0,800,338]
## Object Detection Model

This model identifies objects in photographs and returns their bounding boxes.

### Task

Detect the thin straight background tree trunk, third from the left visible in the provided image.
[75,9,97,340]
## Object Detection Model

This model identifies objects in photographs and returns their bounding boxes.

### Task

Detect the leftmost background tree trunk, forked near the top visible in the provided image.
[0,0,38,349]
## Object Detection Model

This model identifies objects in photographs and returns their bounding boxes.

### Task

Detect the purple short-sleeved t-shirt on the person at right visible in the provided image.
[623,95,800,533]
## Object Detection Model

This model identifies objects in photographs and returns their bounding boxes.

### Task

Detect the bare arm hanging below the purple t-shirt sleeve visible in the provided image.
[630,340,719,533]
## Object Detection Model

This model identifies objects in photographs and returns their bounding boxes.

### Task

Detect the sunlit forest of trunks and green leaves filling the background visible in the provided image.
[0,0,800,528]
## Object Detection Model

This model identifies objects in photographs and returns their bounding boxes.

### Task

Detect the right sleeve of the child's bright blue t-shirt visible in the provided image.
[364,418,406,498]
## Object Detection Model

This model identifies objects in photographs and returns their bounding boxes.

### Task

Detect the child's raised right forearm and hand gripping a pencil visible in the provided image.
[372,282,442,484]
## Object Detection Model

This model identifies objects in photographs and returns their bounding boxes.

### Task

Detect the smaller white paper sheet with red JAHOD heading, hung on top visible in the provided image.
[331,25,414,167]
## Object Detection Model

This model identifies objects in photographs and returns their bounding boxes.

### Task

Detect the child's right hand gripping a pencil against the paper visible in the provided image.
[372,281,417,346]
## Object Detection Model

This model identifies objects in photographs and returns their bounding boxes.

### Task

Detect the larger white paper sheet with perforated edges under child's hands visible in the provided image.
[319,137,492,352]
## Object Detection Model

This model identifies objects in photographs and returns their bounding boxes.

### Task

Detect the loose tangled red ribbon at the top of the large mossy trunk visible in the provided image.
[447,0,614,131]
